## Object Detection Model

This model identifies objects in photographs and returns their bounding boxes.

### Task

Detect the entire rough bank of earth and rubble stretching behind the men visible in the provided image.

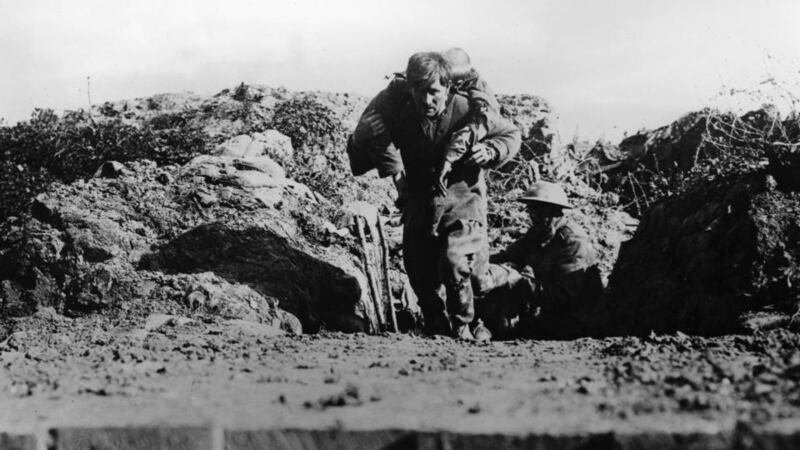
[6,84,800,342]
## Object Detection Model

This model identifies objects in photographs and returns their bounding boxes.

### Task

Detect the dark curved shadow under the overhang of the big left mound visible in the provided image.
[139,223,363,333]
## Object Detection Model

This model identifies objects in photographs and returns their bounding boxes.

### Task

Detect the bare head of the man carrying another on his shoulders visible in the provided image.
[406,52,451,119]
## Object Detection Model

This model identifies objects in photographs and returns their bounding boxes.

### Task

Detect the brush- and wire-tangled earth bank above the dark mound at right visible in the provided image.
[594,105,800,217]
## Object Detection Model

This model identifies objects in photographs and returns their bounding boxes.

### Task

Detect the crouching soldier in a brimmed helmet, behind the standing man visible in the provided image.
[479,182,605,339]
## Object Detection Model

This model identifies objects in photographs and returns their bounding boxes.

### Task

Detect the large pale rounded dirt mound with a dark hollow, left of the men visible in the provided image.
[0,156,382,331]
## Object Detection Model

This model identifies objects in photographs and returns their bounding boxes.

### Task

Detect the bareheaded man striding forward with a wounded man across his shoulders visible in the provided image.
[348,52,521,339]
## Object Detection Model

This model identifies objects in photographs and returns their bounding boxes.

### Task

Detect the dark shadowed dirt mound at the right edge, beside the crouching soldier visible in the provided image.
[609,149,800,334]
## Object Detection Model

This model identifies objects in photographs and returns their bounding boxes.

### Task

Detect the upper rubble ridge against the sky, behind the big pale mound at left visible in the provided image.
[99,83,393,212]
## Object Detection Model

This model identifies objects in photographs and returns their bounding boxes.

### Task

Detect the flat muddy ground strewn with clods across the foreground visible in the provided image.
[0,310,800,433]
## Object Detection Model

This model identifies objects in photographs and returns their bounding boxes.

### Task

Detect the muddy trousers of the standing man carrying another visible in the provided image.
[403,220,489,334]
